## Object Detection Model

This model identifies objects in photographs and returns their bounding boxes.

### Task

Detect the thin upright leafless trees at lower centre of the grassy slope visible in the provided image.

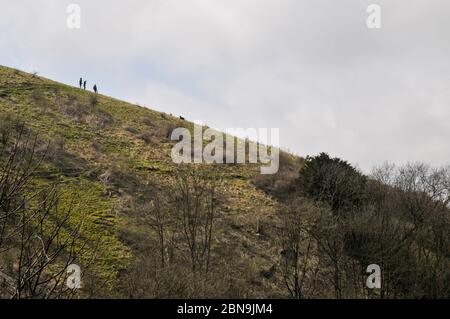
[130,167,225,298]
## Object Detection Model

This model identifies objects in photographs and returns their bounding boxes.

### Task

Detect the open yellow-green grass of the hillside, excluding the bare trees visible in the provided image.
[0,67,299,297]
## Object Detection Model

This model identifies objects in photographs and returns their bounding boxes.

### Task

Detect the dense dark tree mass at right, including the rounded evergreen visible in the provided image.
[280,153,450,298]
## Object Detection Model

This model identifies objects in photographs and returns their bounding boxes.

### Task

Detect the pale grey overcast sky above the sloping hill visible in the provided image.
[0,0,450,171]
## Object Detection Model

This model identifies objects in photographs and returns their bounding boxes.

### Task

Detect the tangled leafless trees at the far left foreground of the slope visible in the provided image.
[0,122,91,298]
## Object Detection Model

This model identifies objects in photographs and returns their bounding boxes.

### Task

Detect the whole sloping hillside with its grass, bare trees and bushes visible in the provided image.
[0,67,450,299]
